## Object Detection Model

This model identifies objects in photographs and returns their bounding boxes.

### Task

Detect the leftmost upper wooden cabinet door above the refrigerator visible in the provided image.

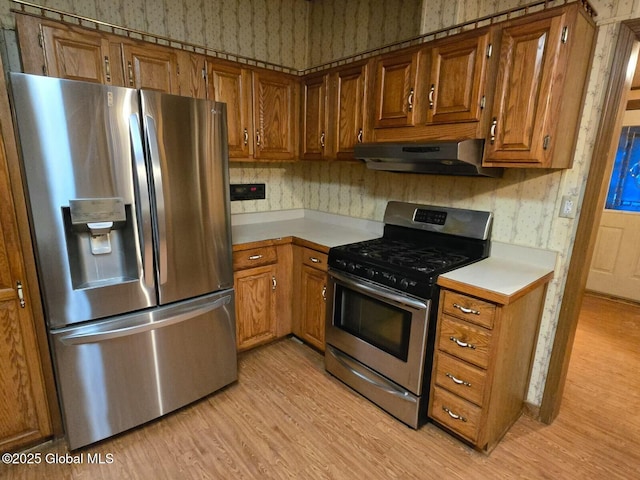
[41,25,112,85]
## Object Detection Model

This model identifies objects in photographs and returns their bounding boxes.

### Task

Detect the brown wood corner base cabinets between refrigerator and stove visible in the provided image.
[233,237,329,351]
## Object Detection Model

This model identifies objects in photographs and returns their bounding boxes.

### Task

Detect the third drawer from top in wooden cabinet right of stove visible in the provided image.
[434,352,487,406]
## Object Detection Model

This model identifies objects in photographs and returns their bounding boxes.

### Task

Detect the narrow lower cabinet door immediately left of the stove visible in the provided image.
[300,265,327,350]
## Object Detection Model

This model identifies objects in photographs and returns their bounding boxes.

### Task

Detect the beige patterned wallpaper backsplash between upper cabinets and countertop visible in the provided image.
[230,162,562,248]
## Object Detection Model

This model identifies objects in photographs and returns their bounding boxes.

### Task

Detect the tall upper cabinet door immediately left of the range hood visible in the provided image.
[331,63,369,159]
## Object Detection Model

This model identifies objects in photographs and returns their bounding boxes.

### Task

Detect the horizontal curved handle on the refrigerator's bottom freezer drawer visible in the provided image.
[59,295,233,345]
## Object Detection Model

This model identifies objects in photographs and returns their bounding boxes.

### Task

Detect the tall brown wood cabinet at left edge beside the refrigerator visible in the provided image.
[0,57,55,454]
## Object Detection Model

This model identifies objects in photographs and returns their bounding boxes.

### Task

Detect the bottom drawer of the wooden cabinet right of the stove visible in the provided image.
[429,387,482,442]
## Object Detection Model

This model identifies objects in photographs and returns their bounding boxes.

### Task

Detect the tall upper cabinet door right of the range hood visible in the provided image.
[485,14,565,163]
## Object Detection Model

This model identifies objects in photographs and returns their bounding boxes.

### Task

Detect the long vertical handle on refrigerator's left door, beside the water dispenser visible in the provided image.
[129,114,154,287]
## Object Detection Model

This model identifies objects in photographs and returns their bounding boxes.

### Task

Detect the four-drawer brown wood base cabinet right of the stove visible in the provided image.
[429,283,547,452]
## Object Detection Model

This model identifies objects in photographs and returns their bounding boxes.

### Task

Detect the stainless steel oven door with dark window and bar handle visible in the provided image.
[326,271,430,395]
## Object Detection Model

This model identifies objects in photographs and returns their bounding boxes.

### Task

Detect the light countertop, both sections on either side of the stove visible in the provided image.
[231,209,557,304]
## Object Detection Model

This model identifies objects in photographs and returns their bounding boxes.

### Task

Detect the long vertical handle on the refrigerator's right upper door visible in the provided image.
[144,115,168,285]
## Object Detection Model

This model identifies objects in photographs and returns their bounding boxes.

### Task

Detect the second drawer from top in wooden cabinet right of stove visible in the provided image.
[438,315,491,368]
